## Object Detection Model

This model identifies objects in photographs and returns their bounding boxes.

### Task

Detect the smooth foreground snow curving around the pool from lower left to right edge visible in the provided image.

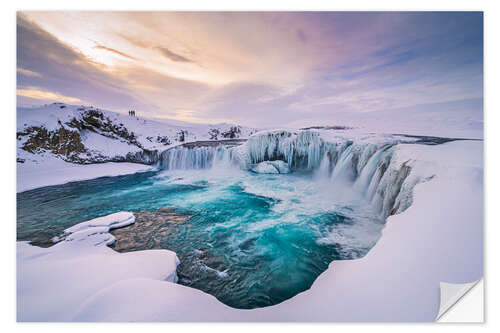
[17,141,483,321]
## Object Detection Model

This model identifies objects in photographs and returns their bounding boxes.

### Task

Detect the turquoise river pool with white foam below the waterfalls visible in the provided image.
[17,170,384,308]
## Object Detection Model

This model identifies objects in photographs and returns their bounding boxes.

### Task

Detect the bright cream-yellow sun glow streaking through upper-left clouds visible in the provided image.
[23,12,233,86]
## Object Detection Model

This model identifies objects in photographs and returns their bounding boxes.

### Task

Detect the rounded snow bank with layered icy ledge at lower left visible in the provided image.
[17,212,179,321]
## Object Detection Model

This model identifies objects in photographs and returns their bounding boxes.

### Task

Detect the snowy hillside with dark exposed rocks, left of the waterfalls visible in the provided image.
[17,103,256,164]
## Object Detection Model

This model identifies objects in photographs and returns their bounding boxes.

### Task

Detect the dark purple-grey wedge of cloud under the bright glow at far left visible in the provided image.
[17,15,141,109]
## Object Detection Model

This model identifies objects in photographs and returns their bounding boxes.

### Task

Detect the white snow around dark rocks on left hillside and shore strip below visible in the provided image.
[17,103,256,192]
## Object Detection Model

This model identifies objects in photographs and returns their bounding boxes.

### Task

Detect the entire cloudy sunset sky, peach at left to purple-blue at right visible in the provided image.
[17,11,483,127]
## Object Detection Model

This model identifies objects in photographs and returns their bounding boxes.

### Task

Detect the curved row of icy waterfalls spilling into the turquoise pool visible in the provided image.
[160,130,430,217]
